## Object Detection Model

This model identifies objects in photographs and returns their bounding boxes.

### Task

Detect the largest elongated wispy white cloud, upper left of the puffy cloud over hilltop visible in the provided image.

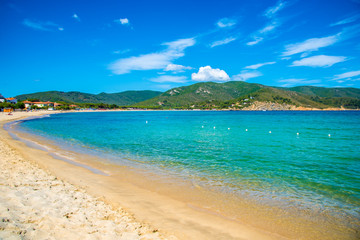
[109,38,195,74]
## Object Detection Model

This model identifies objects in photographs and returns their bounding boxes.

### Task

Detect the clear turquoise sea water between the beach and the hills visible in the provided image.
[12,111,360,232]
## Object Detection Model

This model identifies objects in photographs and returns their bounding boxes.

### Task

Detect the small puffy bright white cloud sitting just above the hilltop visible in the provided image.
[191,66,230,82]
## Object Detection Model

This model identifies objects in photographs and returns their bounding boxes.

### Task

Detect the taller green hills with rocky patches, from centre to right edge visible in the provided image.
[134,81,360,109]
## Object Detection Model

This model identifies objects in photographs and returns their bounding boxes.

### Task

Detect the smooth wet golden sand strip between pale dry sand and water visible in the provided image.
[0,112,281,239]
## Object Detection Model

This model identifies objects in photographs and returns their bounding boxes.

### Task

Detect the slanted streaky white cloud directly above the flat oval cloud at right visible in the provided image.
[282,34,340,56]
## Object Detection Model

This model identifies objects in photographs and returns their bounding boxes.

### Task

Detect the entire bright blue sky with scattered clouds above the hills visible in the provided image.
[0,0,360,97]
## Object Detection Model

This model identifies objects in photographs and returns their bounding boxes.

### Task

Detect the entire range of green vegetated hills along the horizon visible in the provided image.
[9,81,360,109]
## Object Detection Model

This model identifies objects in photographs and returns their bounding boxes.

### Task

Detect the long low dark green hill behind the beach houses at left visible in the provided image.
[16,90,162,106]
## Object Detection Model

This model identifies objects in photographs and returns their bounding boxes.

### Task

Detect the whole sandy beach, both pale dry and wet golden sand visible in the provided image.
[0,112,282,239]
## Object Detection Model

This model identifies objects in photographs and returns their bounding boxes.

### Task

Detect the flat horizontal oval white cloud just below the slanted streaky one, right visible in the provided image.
[291,55,347,67]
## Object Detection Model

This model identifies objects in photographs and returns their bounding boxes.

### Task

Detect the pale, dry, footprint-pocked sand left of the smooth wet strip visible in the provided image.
[0,113,164,239]
